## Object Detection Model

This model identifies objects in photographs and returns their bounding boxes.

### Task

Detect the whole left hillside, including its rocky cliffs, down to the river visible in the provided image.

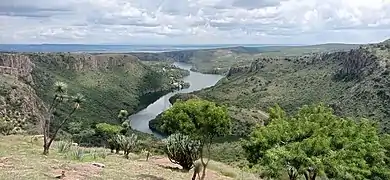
[0,53,185,137]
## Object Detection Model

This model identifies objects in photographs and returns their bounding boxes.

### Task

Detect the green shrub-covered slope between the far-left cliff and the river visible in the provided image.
[21,53,189,146]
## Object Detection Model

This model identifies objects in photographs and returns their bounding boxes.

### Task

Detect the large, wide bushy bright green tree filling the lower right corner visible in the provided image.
[243,104,390,180]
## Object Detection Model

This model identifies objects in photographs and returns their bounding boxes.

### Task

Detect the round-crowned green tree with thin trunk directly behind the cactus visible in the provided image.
[161,99,231,179]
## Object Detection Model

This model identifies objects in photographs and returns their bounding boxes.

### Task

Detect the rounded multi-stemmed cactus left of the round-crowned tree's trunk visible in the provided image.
[163,134,200,171]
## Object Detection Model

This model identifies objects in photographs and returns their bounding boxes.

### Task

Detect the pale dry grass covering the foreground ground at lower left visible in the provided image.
[0,136,258,180]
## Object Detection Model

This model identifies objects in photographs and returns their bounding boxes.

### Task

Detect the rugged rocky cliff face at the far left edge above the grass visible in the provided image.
[0,53,46,133]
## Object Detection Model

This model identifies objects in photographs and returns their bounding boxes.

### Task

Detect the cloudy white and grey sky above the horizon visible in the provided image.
[0,0,390,44]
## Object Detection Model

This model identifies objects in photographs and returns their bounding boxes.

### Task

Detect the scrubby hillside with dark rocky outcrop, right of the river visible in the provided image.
[191,40,390,132]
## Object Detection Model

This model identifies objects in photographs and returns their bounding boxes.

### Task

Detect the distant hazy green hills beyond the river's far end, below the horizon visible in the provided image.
[131,44,358,74]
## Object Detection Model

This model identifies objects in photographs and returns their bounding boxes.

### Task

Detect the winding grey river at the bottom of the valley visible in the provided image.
[130,62,223,137]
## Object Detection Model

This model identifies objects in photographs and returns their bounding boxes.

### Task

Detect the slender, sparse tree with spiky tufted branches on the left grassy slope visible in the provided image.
[43,82,85,155]
